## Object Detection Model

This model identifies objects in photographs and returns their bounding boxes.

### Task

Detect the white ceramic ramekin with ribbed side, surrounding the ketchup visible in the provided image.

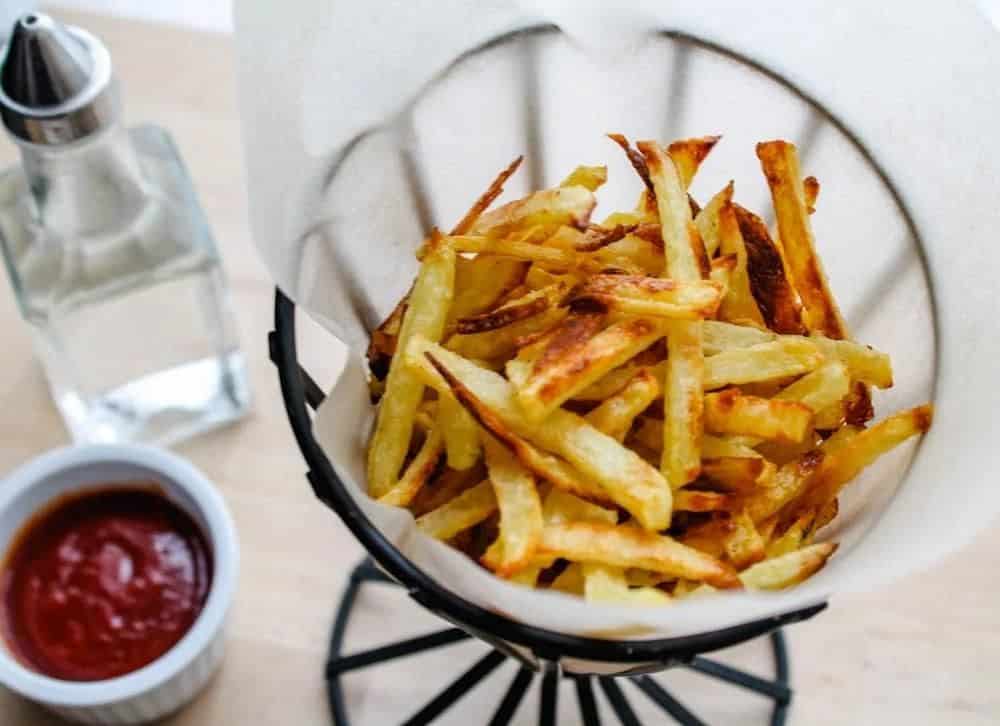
[0,444,239,724]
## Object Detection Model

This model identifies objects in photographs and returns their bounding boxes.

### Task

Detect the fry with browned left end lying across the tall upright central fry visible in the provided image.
[569,275,722,320]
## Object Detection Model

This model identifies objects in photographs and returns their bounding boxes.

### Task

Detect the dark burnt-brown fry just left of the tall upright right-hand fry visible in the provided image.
[733,204,805,333]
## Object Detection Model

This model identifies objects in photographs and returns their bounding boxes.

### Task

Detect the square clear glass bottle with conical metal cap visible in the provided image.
[0,13,250,445]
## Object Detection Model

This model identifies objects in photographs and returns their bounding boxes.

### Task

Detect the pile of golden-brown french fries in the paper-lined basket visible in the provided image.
[368,135,932,605]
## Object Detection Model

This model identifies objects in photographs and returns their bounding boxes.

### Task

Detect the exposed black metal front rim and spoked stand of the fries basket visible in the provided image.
[268,291,826,726]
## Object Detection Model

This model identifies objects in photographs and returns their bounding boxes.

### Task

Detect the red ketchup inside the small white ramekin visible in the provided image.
[0,484,212,681]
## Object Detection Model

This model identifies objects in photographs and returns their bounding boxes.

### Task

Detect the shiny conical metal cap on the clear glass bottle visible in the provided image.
[0,13,118,145]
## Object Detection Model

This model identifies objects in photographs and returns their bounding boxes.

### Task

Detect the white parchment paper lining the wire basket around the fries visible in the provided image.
[236,0,1000,636]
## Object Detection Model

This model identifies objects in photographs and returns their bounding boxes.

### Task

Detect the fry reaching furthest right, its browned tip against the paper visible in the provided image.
[796,404,934,511]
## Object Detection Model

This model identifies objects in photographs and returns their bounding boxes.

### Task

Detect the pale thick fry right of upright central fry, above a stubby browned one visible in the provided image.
[704,337,824,390]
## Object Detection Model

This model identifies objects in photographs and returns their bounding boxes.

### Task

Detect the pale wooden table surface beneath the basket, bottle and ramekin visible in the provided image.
[0,13,1000,726]
